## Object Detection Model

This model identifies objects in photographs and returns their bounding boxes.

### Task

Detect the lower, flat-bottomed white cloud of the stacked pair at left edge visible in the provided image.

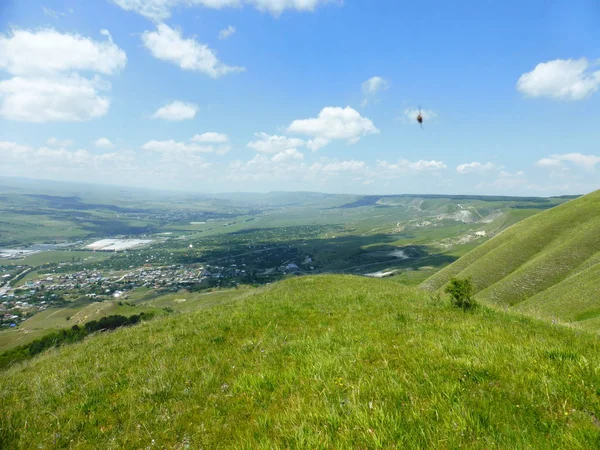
[0,75,110,123]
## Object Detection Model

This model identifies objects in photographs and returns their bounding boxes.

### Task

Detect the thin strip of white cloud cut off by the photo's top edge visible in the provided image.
[112,0,342,22]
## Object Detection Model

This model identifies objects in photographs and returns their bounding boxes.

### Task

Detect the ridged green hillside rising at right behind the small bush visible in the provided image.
[423,191,600,325]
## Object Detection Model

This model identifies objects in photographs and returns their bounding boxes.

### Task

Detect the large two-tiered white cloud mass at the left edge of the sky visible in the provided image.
[0,29,127,122]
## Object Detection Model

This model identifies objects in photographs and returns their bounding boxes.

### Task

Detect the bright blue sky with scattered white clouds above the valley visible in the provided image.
[0,0,600,196]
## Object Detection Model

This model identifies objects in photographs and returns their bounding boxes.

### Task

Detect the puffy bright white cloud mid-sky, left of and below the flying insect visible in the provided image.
[287,106,379,150]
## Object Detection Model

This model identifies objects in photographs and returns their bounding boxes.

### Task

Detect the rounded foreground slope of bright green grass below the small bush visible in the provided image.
[0,276,600,449]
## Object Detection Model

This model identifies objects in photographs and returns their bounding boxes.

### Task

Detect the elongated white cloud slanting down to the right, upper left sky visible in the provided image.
[142,23,245,78]
